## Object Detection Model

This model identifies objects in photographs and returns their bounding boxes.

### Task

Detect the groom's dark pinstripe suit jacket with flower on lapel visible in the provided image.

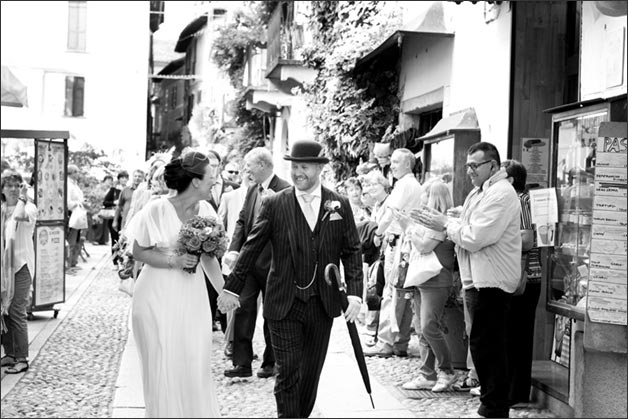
[224,187,363,320]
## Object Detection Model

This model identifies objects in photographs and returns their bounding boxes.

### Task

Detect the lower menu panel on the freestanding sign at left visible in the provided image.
[33,224,65,306]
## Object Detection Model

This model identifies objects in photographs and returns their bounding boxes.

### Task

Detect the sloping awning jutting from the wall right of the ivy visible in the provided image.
[353,1,454,73]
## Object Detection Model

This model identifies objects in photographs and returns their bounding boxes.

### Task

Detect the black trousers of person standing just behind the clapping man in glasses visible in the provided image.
[508,282,541,406]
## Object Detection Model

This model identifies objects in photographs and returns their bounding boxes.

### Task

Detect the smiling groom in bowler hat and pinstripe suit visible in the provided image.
[218,140,363,417]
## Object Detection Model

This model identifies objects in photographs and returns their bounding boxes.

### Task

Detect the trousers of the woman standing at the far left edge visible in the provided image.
[2,265,32,359]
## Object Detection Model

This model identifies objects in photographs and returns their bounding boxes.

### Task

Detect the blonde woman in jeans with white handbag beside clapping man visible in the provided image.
[403,180,456,392]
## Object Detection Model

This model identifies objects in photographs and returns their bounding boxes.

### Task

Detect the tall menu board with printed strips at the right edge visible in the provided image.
[587,122,628,325]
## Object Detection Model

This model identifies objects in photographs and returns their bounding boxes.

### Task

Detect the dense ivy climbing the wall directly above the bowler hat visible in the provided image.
[303,1,401,180]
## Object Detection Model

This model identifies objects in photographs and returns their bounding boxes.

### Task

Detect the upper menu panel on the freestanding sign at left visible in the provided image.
[35,140,66,221]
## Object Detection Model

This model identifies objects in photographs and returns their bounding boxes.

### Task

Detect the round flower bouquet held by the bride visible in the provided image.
[177,215,227,273]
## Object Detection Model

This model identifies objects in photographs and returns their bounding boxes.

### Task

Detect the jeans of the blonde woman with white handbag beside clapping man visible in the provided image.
[414,287,454,380]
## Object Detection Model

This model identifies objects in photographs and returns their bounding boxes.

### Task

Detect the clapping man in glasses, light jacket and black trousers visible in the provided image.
[413,142,521,418]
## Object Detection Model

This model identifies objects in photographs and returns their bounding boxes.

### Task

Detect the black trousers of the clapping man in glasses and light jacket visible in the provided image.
[469,288,512,418]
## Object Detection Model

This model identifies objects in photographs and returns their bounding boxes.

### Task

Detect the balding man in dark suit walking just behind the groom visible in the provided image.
[223,147,290,378]
